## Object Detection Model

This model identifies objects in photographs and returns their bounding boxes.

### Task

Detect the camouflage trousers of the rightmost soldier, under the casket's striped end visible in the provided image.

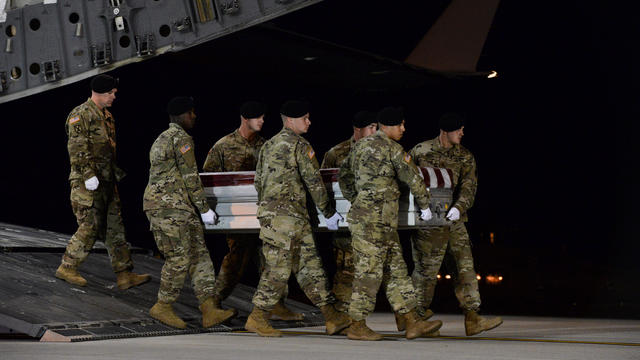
[411,222,480,311]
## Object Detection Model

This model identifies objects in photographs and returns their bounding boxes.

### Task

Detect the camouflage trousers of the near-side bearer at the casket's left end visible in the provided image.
[146,209,216,304]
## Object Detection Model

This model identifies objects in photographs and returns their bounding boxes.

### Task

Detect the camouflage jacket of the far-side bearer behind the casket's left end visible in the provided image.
[202,130,264,172]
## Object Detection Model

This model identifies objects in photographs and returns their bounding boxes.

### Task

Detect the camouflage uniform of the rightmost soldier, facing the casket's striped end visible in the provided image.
[409,138,480,311]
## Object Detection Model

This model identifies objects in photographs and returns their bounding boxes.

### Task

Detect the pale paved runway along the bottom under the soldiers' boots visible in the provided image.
[0,313,640,360]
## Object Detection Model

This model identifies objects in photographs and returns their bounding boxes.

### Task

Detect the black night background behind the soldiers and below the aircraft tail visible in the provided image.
[0,0,640,318]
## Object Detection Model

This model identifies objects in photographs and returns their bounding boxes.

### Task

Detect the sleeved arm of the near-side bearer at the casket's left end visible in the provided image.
[173,137,209,214]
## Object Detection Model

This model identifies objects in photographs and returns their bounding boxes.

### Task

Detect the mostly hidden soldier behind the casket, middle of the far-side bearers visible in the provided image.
[320,111,378,312]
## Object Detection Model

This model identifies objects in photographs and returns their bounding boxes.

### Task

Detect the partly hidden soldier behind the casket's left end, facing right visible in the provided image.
[203,101,304,320]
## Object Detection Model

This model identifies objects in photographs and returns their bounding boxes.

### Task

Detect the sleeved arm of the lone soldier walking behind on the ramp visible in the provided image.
[67,113,96,180]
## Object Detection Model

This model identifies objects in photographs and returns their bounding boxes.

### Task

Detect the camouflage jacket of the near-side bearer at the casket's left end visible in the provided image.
[143,123,209,215]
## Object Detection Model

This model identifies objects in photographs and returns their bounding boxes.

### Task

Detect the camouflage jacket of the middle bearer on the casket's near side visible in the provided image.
[255,127,335,219]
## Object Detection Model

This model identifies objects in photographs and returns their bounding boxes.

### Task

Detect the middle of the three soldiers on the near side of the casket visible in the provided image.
[245,101,350,336]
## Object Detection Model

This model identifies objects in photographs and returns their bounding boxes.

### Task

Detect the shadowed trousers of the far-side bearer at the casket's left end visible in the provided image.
[215,234,264,300]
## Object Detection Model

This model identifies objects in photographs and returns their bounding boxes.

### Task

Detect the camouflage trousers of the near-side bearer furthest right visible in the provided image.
[349,223,417,321]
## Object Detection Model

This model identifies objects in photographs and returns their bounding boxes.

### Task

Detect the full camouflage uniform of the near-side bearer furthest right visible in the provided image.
[339,131,429,321]
